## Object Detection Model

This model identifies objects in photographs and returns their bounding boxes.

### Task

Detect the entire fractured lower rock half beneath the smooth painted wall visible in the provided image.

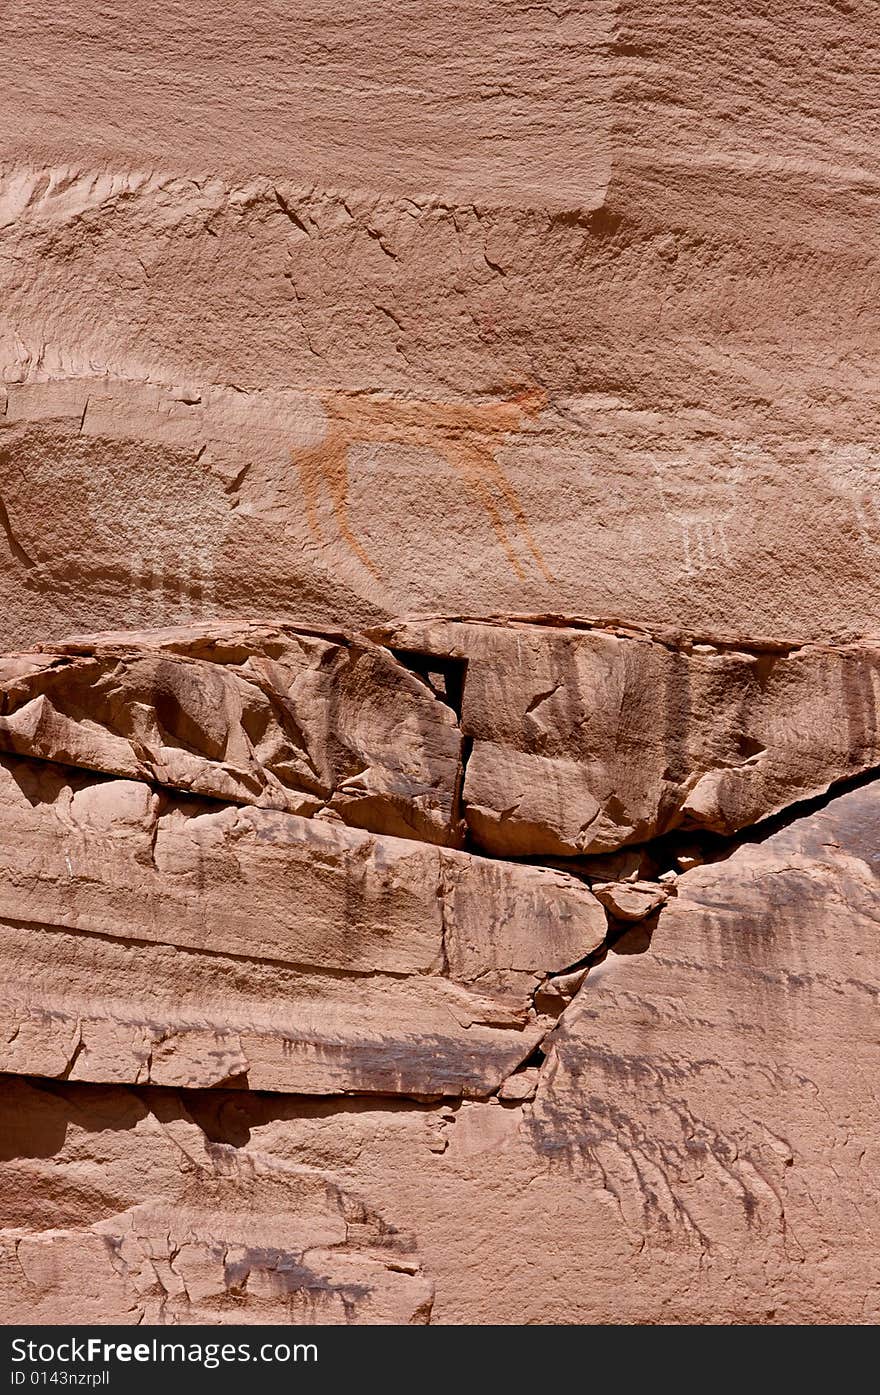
[0,622,880,1322]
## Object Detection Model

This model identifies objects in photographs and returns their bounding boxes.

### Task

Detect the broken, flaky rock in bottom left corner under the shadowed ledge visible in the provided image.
[0,1078,434,1324]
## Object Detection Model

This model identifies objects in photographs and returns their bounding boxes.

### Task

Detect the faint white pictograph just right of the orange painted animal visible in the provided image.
[654,445,750,576]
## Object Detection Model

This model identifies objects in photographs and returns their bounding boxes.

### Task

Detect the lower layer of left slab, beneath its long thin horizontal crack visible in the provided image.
[0,922,548,1096]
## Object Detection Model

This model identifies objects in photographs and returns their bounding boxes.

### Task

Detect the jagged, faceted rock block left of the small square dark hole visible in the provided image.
[0,626,462,844]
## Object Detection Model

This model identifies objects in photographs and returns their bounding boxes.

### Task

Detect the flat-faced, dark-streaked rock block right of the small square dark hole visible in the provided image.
[379,621,880,857]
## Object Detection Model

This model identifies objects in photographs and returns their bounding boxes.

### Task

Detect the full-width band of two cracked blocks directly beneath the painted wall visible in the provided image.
[0,622,880,858]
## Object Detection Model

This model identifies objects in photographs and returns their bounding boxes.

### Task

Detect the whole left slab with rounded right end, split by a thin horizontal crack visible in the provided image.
[0,757,605,1095]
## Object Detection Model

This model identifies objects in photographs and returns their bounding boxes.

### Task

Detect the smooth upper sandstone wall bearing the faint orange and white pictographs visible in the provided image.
[0,0,880,646]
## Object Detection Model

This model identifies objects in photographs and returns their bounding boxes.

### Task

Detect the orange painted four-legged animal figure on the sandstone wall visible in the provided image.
[290,388,554,580]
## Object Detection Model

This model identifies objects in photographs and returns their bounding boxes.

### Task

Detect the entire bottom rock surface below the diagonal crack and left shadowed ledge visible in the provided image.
[0,784,880,1324]
